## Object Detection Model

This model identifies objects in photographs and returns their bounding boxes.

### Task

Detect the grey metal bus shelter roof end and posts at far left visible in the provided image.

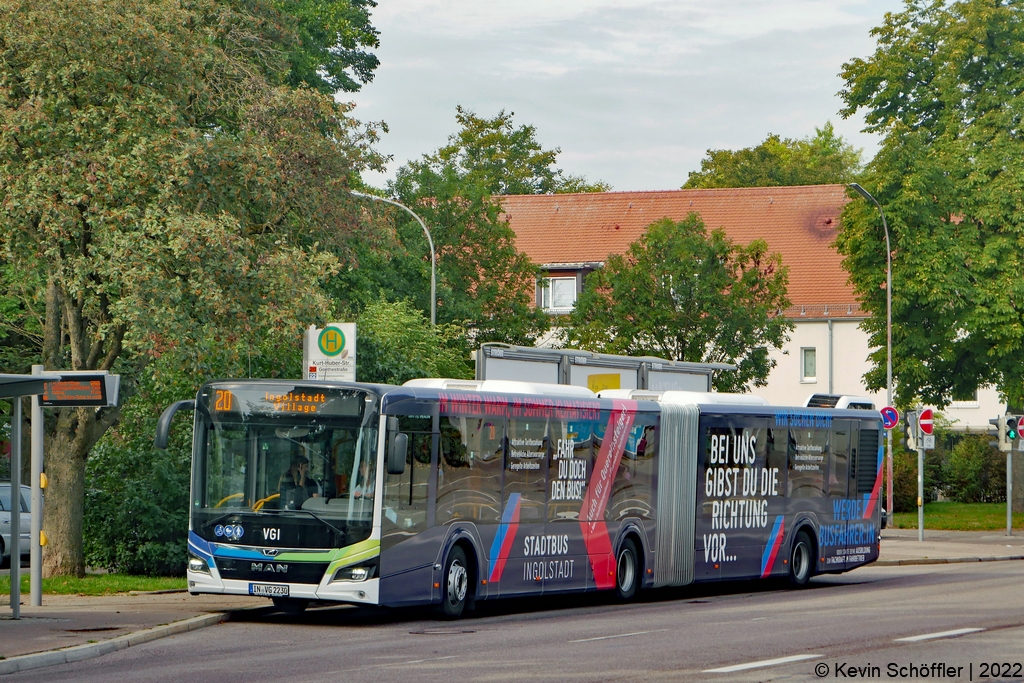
[0,374,60,618]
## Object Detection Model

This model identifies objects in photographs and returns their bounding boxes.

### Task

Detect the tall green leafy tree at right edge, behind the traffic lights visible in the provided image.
[837,0,1024,407]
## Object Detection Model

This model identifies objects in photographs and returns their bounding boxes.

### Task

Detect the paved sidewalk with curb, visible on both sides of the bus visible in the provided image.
[0,529,1024,675]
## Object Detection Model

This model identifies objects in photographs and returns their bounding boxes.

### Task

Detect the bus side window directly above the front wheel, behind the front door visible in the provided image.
[434,416,505,524]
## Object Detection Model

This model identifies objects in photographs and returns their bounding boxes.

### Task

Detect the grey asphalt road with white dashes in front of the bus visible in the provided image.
[9,562,1024,683]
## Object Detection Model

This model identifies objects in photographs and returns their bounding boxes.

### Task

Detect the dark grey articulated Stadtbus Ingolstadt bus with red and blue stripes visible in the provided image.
[157,380,882,617]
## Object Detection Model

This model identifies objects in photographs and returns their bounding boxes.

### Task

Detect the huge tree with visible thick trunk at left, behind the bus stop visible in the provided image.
[0,0,378,575]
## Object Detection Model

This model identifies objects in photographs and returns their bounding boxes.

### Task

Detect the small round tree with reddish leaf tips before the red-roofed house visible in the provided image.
[567,214,793,391]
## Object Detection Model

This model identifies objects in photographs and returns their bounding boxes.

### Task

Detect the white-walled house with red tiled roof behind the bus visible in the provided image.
[502,184,1006,432]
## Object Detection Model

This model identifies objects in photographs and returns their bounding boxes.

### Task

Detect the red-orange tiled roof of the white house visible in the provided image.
[500,185,863,317]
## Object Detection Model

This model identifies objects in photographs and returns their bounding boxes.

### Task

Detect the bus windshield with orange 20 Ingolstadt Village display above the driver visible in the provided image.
[193,382,379,548]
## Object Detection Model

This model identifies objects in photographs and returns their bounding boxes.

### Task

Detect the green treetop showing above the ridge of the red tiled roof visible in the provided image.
[683,122,860,189]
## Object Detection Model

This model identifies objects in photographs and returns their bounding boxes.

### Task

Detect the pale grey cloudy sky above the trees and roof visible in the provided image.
[350,0,902,190]
